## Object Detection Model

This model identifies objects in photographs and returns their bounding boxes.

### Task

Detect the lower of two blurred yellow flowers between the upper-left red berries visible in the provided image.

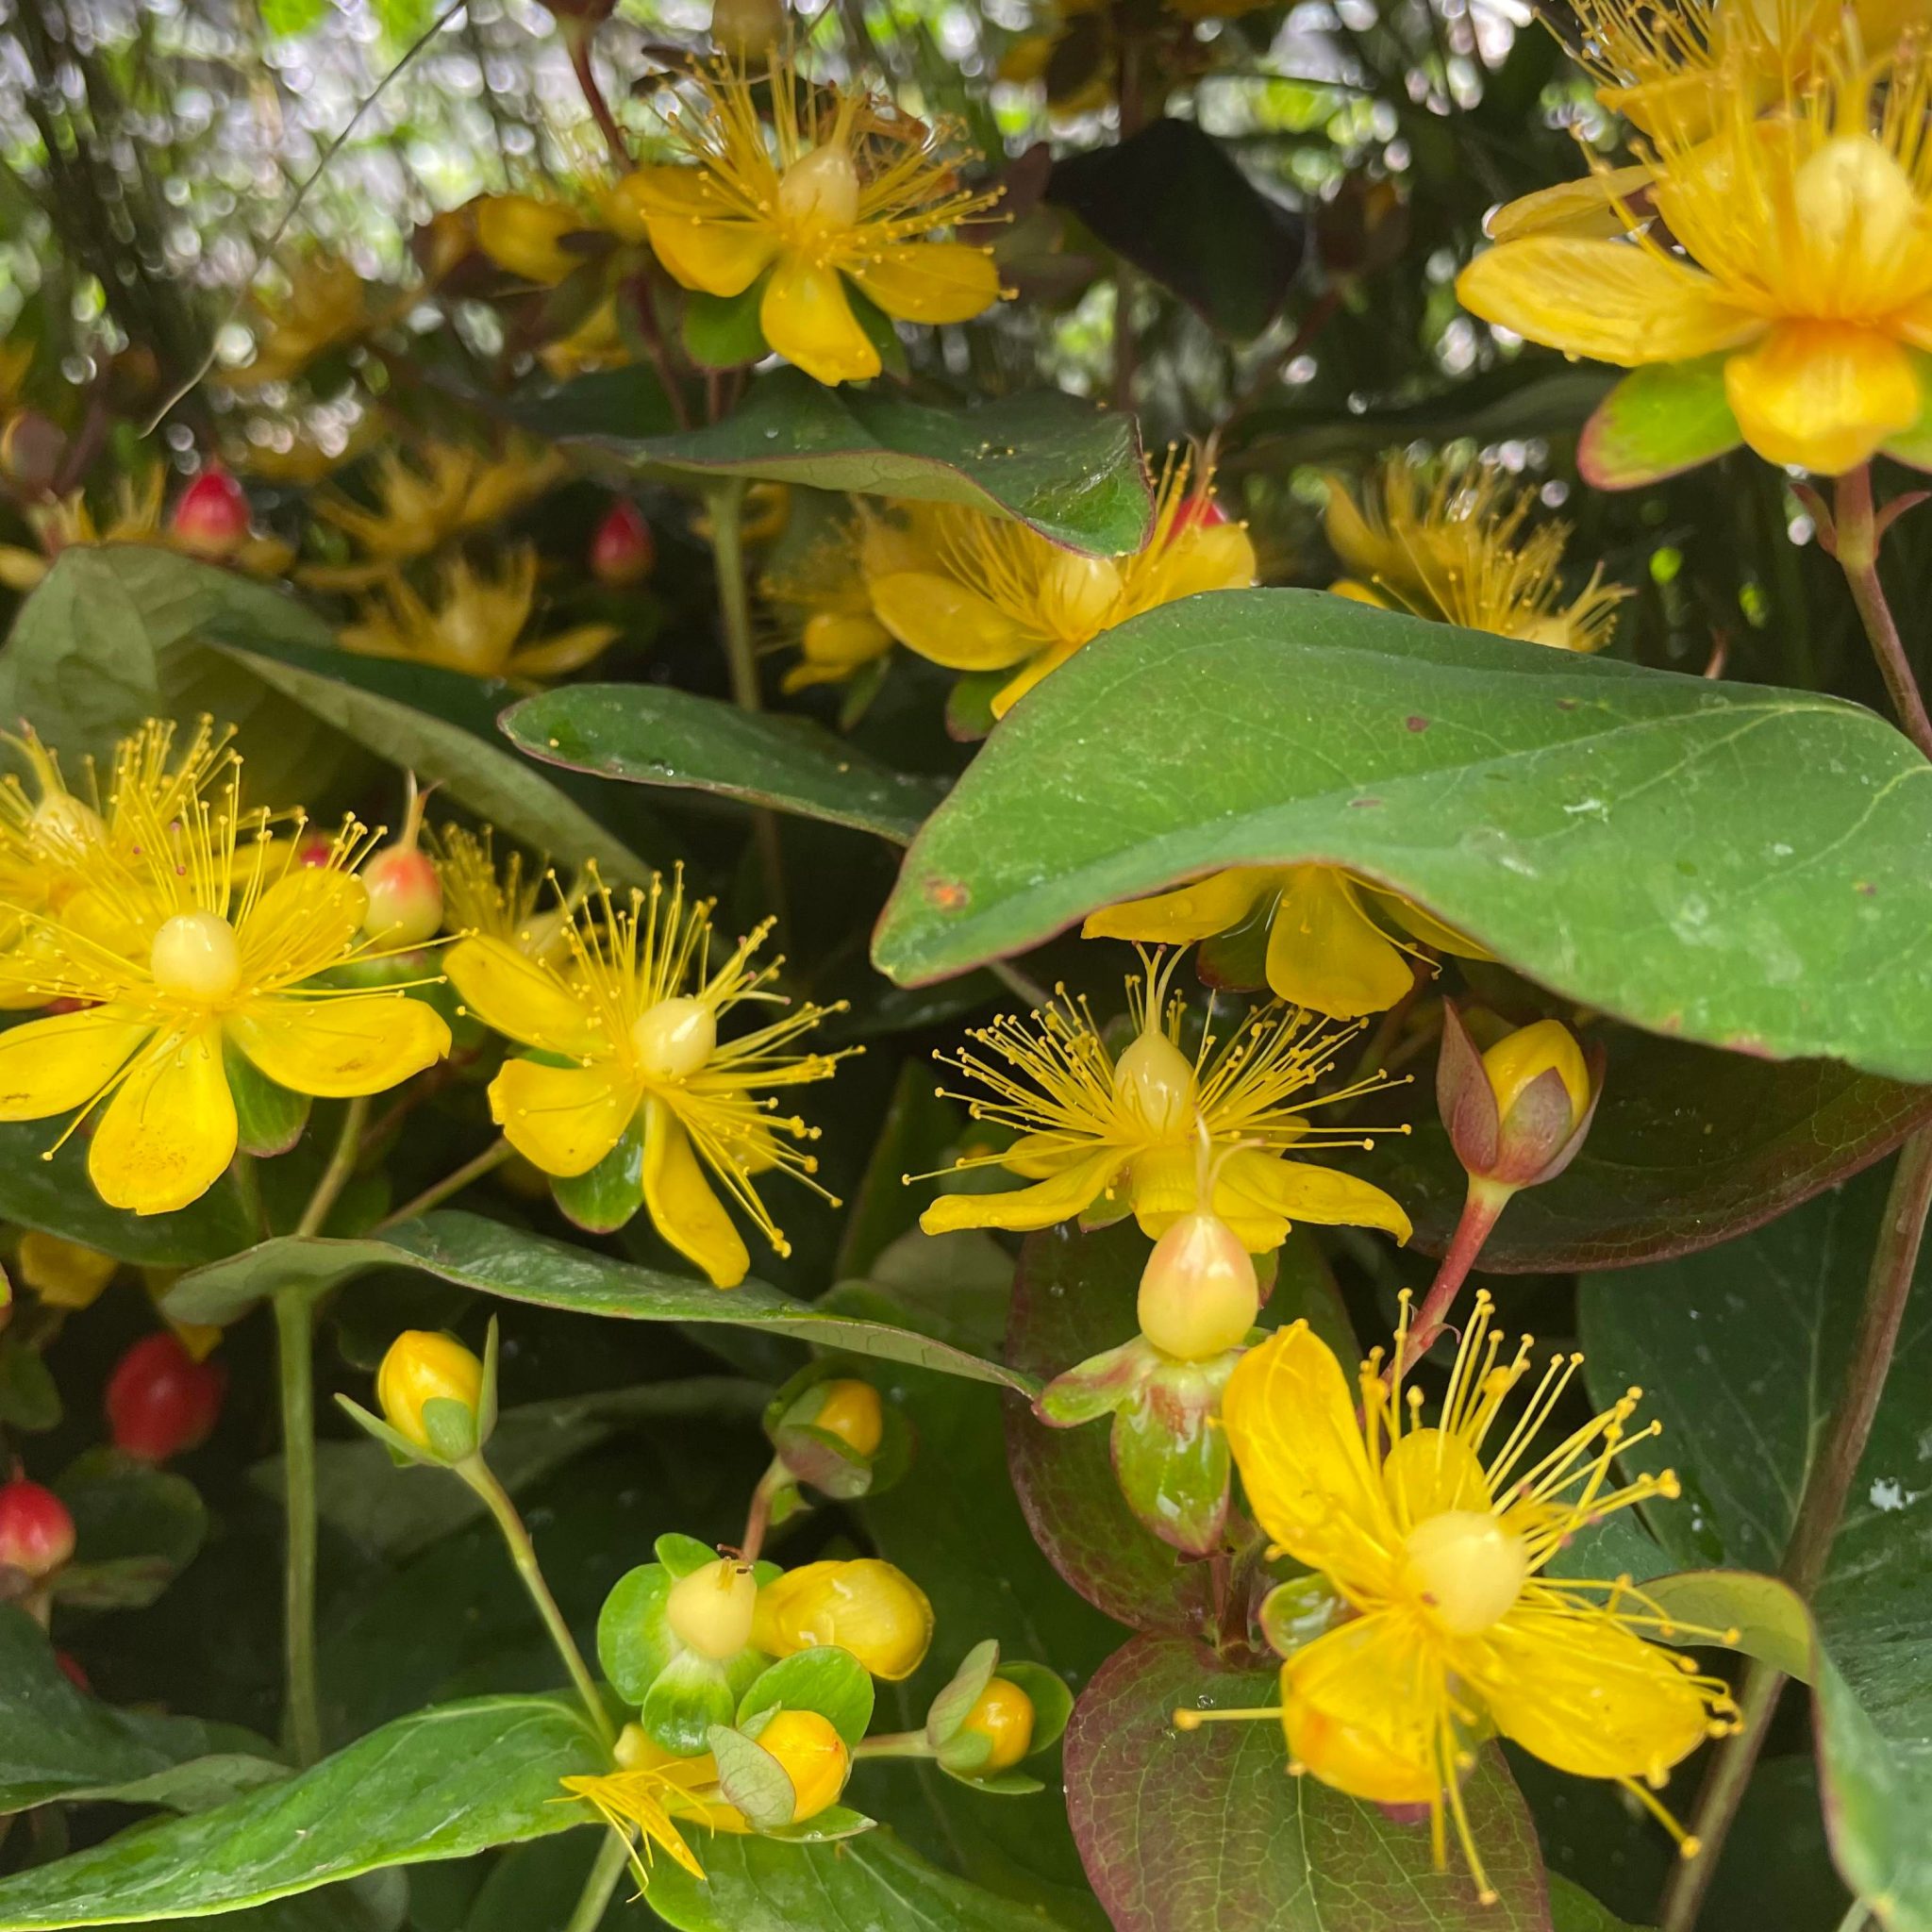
[340,545,616,678]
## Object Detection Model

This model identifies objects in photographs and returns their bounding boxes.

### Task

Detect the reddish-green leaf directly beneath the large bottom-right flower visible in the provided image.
[1066,1637,1549,1932]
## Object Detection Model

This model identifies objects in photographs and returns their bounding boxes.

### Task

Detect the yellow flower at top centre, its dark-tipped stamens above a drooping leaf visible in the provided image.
[616,58,999,383]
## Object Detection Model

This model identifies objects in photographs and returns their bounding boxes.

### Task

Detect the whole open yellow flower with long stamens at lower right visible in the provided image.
[1174,1294,1737,1899]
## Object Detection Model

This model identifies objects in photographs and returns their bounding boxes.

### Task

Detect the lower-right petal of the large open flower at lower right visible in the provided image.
[1468,1609,1709,1777]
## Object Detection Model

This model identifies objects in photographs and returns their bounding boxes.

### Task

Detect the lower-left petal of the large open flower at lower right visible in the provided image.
[1281,1611,1447,1805]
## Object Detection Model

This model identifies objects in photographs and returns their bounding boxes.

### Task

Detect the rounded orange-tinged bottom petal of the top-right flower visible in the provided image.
[1724,323,1921,475]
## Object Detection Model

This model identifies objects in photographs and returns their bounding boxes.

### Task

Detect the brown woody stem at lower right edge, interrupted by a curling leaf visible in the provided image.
[1659,1128,1932,1932]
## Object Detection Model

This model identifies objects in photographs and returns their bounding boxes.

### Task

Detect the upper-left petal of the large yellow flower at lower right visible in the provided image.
[1221,1322,1393,1576]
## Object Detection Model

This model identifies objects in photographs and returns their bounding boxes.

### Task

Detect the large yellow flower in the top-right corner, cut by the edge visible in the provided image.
[1457,41,1932,475]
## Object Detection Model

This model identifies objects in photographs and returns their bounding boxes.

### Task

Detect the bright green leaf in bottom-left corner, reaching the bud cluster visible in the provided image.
[0,1696,605,1932]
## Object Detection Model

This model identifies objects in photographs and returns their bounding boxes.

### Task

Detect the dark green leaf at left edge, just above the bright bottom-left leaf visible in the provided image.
[0,1604,288,1814]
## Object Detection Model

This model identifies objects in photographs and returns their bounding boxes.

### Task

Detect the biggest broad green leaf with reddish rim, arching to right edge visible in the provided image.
[874,591,1932,1080]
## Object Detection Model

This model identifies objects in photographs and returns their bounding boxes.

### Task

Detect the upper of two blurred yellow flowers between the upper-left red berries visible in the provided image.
[301,442,566,590]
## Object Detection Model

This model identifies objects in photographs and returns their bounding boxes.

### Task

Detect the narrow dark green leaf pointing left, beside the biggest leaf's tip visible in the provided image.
[502,684,942,844]
